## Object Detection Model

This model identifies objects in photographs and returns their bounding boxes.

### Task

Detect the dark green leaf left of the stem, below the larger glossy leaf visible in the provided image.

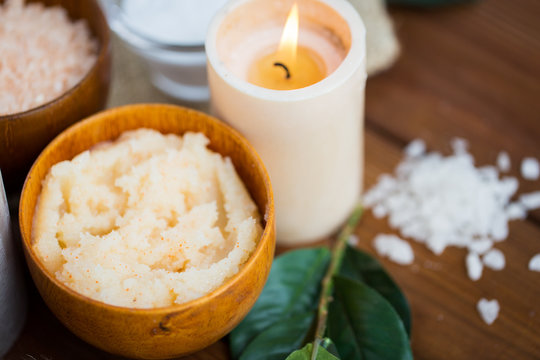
[240,311,316,360]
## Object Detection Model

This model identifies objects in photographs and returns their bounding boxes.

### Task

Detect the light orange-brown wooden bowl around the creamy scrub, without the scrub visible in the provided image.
[19,104,275,359]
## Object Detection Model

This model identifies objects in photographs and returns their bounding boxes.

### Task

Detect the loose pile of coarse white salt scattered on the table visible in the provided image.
[364,139,540,322]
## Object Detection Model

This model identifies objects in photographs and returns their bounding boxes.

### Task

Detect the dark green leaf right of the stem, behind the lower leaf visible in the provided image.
[339,246,411,335]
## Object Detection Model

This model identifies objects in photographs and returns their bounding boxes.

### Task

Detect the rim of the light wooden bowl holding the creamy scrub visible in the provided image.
[19,103,275,315]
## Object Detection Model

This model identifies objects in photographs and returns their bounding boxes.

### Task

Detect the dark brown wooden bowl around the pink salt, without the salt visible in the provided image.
[0,0,111,190]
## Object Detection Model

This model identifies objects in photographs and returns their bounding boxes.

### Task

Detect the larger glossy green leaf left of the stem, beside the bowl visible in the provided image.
[230,248,330,359]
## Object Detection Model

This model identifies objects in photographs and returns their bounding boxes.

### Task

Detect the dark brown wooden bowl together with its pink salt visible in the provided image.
[0,0,111,191]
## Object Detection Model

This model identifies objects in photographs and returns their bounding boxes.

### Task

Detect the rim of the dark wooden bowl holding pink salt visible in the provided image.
[0,0,111,122]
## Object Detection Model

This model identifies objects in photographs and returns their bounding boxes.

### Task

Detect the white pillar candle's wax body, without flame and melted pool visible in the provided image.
[206,0,366,245]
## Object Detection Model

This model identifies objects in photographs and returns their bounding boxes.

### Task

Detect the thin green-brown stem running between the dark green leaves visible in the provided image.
[311,203,364,360]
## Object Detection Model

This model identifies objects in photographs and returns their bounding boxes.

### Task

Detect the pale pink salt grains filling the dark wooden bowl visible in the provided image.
[0,0,98,116]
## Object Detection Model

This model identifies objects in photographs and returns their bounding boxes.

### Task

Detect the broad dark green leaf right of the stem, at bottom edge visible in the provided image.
[327,276,412,360]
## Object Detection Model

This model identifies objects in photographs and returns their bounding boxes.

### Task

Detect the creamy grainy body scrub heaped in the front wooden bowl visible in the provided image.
[32,129,262,308]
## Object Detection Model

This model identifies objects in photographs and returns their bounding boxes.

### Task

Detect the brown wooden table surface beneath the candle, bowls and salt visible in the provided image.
[6,0,540,360]
